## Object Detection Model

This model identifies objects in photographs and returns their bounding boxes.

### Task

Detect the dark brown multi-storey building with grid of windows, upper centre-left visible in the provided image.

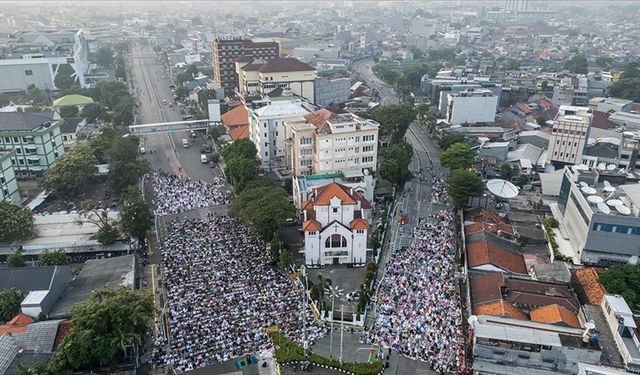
[213,38,280,96]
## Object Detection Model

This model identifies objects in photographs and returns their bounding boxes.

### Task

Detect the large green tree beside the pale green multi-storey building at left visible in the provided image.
[42,143,96,198]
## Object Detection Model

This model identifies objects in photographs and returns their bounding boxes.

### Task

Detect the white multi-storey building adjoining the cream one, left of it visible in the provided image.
[246,97,310,169]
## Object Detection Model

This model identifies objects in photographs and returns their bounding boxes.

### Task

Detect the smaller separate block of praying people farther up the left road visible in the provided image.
[153,171,229,216]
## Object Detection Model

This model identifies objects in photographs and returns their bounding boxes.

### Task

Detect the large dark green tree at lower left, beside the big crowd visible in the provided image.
[50,287,154,373]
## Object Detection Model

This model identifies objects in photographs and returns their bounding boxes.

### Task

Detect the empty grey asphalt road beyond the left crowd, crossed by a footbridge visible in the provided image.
[130,44,221,181]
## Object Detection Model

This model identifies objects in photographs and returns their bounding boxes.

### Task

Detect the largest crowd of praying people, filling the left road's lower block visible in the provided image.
[156,215,327,373]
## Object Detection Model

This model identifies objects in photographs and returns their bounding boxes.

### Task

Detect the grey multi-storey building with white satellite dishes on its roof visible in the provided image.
[556,165,640,265]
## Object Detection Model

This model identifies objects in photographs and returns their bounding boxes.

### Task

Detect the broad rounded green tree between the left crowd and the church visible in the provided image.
[229,178,296,242]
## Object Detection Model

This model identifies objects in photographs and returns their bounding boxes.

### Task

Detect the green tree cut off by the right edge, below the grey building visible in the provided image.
[600,264,640,313]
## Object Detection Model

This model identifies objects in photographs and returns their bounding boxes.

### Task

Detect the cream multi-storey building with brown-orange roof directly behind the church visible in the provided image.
[285,109,380,176]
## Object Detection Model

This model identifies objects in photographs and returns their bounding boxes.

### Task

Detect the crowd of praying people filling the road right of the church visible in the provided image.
[362,179,465,374]
